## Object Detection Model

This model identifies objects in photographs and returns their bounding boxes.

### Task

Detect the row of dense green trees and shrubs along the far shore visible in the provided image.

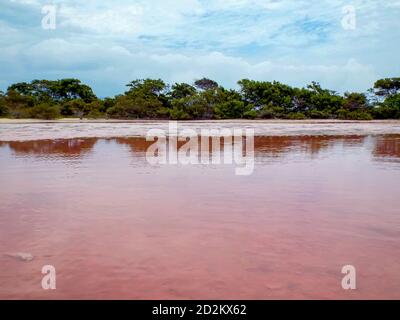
[0,78,400,120]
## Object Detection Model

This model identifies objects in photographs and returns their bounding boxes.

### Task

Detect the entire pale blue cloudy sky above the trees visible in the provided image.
[0,0,400,97]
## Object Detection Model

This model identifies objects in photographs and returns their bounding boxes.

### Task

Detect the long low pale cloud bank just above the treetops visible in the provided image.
[0,39,377,95]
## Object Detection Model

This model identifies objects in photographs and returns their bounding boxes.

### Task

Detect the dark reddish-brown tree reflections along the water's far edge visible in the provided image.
[0,135,400,161]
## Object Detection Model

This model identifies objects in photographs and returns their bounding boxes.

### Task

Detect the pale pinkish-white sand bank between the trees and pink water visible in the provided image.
[0,119,400,141]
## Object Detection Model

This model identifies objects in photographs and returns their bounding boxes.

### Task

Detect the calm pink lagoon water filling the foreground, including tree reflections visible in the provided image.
[0,135,400,299]
